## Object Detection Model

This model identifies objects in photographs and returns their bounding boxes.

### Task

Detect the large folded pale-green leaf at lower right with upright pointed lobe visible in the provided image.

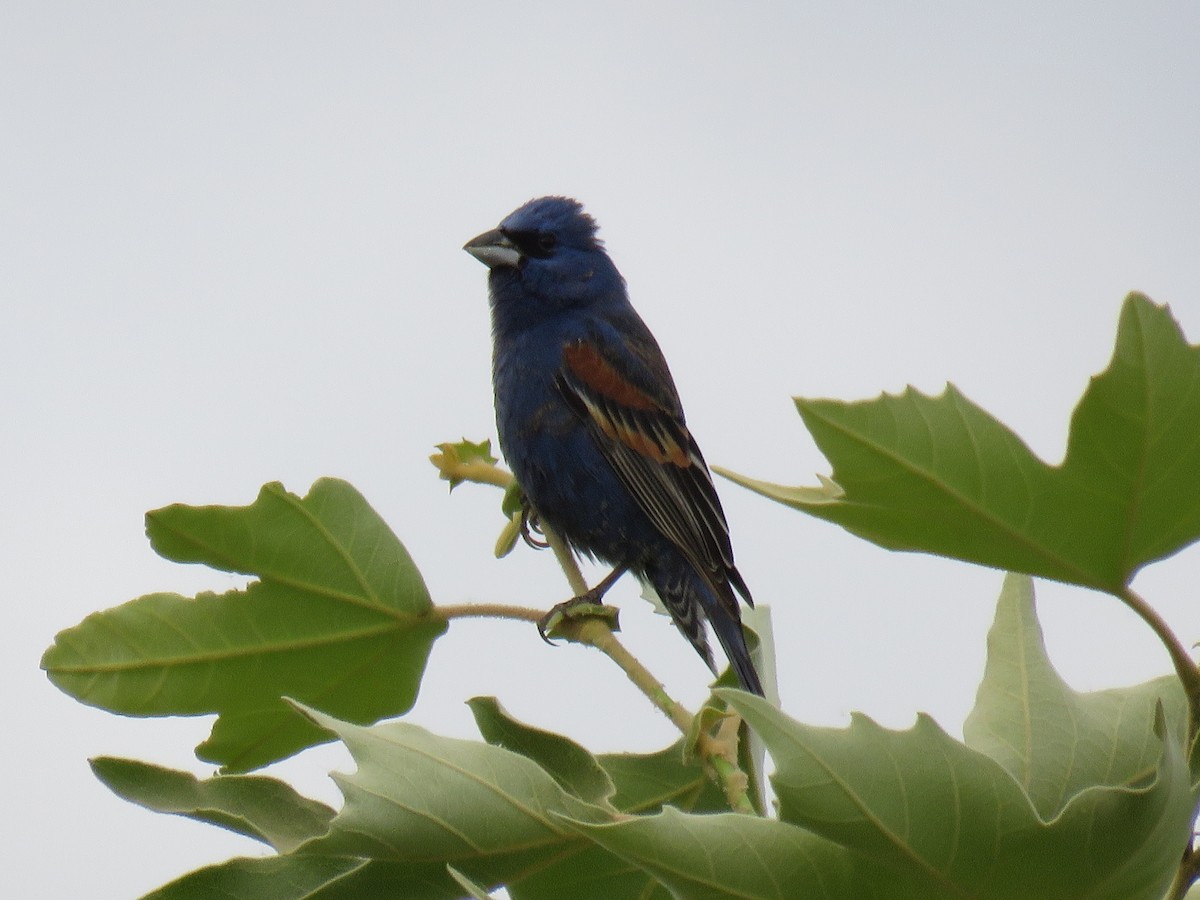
[719,580,1195,900]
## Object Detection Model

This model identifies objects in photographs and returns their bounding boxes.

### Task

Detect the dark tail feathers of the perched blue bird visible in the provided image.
[647,565,766,697]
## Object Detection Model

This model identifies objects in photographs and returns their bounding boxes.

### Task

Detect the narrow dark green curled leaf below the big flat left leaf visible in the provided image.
[91,756,334,853]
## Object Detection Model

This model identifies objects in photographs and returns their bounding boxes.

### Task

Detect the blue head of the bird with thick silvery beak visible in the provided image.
[463,197,624,316]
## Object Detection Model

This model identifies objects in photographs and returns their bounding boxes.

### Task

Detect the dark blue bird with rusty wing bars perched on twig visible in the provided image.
[463,197,763,696]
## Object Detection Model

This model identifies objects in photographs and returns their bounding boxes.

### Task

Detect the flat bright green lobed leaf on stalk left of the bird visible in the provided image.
[42,479,445,770]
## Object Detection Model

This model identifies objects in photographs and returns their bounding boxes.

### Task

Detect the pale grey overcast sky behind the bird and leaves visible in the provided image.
[7,1,1200,900]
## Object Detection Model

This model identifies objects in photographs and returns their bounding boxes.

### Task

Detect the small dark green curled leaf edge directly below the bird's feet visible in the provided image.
[467,697,614,805]
